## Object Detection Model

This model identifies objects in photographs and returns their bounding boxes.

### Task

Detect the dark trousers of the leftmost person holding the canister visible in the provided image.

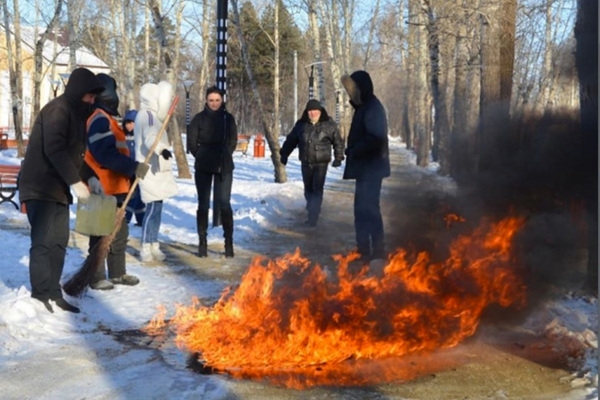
[26,200,69,301]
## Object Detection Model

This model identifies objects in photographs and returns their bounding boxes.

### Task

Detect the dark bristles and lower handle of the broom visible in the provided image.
[63,209,125,297]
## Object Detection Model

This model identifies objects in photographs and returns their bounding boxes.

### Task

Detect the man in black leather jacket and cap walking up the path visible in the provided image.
[279,99,344,226]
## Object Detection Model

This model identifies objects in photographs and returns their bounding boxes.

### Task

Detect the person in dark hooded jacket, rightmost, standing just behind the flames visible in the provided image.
[342,71,390,260]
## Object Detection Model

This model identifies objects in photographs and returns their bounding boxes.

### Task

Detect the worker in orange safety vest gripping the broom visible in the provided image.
[85,73,149,290]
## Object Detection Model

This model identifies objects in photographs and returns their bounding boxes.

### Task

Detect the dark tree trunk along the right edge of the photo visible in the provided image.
[575,0,598,294]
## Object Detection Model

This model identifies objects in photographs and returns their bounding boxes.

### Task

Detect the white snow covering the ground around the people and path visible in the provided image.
[0,141,598,400]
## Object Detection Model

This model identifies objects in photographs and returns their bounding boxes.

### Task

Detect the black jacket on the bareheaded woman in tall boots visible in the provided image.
[187,105,237,174]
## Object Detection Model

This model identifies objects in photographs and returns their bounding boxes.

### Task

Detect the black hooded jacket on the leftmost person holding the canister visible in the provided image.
[19,68,103,204]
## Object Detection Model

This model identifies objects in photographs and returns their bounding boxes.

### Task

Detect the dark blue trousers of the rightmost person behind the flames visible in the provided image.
[354,178,385,258]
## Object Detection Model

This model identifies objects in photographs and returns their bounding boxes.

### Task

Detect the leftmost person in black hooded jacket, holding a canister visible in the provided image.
[19,68,104,313]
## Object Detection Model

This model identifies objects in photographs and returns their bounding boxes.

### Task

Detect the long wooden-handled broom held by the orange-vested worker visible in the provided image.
[63,96,179,296]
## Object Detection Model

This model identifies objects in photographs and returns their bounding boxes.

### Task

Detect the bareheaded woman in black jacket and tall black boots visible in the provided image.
[187,86,237,258]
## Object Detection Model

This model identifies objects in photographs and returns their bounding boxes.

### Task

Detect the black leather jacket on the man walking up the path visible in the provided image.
[279,107,344,164]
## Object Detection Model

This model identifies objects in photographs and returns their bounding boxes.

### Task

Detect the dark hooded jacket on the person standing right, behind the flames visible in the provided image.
[342,71,390,179]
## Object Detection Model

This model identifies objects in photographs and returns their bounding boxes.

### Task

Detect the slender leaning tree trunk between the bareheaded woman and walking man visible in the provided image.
[231,0,287,183]
